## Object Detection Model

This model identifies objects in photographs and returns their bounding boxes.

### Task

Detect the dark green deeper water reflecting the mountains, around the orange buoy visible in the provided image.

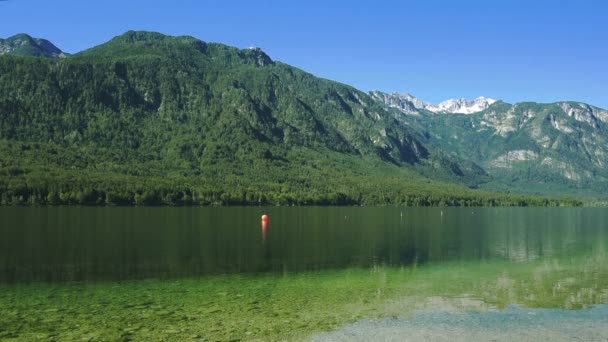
[0,207,608,283]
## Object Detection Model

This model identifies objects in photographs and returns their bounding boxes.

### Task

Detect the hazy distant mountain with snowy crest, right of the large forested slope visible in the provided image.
[372,92,608,196]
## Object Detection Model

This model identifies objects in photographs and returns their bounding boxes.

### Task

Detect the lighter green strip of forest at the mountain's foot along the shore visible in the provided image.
[0,142,580,206]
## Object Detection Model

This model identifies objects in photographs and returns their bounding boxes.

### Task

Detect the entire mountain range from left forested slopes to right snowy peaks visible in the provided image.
[0,31,592,205]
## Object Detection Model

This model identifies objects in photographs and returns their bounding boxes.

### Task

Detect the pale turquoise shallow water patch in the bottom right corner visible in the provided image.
[311,305,608,342]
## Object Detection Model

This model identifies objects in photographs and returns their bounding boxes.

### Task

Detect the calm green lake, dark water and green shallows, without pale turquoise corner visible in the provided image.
[0,207,608,341]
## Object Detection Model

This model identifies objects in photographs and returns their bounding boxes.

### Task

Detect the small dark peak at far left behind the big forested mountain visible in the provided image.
[0,33,68,58]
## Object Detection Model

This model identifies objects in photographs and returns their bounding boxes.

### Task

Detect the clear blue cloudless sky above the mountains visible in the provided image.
[0,0,608,108]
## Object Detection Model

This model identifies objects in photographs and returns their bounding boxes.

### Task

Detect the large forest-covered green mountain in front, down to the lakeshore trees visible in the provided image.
[0,32,580,206]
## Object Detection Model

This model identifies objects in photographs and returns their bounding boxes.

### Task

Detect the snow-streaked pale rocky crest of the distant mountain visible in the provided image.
[370,91,496,114]
